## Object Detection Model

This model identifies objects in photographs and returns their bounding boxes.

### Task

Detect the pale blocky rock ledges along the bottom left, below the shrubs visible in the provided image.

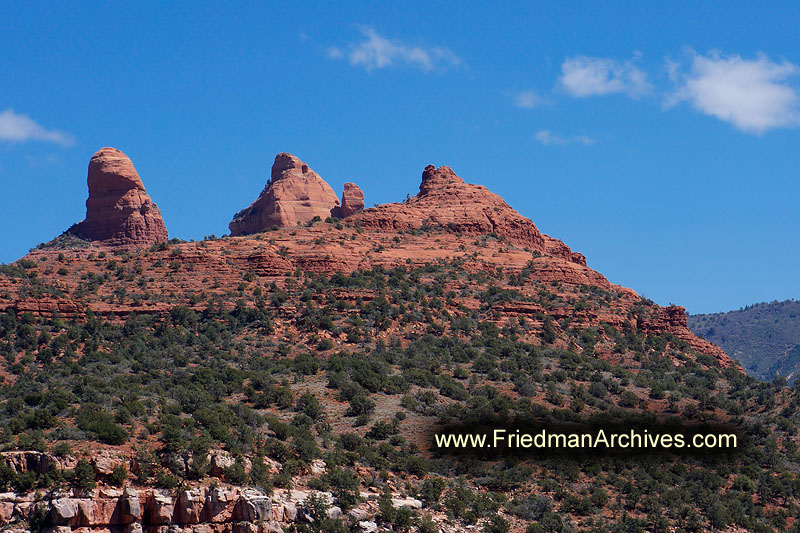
[0,452,422,533]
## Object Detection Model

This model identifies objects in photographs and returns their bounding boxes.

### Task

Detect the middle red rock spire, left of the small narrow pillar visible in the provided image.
[228,153,339,236]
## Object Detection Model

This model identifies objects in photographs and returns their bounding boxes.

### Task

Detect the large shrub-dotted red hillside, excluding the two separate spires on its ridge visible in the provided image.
[0,162,800,533]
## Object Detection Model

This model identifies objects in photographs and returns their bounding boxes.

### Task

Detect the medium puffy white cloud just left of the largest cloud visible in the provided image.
[559,56,650,97]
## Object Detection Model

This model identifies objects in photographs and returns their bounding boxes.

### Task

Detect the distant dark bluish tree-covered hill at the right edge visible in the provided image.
[689,300,800,381]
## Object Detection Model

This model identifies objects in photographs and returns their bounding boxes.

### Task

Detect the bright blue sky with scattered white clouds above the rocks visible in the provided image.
[0,1,800,312]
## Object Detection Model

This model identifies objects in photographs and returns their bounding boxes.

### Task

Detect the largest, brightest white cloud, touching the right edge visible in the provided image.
[667,52,800,134]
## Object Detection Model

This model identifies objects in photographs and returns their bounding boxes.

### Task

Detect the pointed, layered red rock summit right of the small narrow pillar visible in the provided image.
[353,165,586,265]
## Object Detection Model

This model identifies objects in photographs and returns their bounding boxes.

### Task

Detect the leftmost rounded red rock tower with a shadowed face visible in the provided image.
[70,148,169,248]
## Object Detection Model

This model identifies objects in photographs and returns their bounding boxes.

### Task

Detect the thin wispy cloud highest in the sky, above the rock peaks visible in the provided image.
[327,26,462,72]
